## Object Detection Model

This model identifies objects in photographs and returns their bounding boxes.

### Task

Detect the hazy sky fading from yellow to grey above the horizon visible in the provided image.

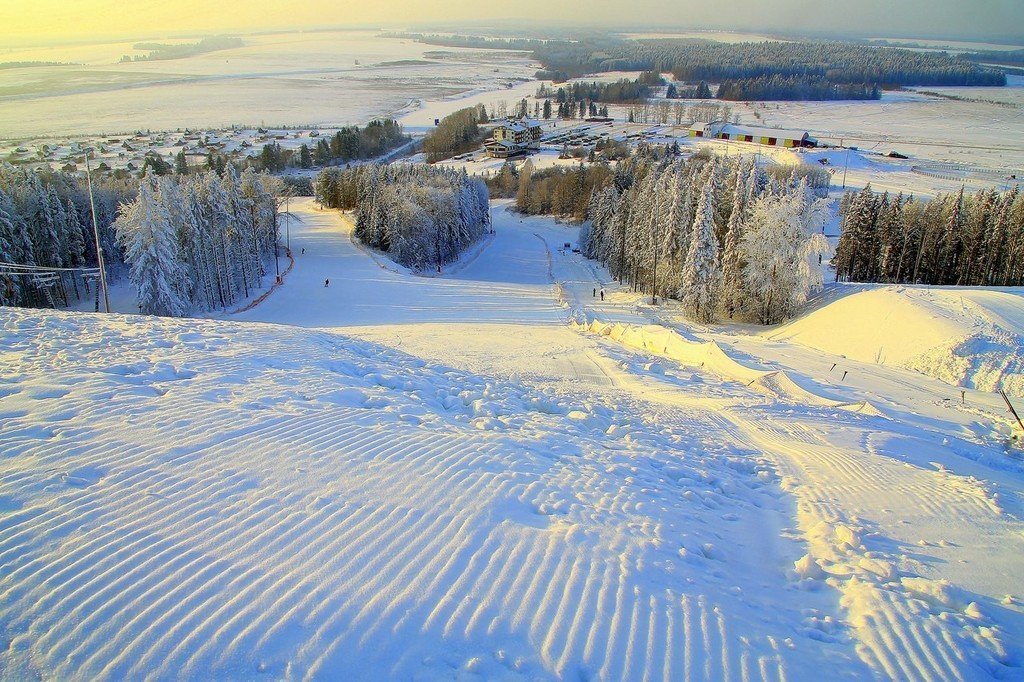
[0,0,1024,47]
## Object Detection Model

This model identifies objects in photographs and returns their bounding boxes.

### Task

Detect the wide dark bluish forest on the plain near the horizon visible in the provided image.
[403,35,1007,99]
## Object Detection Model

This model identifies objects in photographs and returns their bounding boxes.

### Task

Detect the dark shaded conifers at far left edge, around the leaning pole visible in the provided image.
[0,164,135,307]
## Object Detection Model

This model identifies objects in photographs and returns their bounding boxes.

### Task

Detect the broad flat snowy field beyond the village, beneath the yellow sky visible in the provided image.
[0,31,537,139]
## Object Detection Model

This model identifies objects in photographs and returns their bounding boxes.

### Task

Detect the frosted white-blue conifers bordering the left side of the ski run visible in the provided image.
[114,166,279,316]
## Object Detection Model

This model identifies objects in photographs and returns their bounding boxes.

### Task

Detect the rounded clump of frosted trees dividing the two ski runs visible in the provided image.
[314,164,490,270]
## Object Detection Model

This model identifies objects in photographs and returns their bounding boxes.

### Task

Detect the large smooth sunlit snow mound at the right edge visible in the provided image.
[768,286,1024,396]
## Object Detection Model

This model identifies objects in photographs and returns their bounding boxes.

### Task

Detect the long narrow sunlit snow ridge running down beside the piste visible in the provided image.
[570,315,881,415]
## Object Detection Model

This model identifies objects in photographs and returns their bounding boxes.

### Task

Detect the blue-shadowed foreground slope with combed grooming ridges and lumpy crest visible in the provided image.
[0,309,843,679]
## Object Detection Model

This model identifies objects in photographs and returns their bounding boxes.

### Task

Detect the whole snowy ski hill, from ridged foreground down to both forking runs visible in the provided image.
[0,203,1024,680]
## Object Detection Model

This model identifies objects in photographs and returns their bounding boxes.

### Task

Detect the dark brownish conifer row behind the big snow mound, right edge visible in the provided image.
[833,185,1024,287]
